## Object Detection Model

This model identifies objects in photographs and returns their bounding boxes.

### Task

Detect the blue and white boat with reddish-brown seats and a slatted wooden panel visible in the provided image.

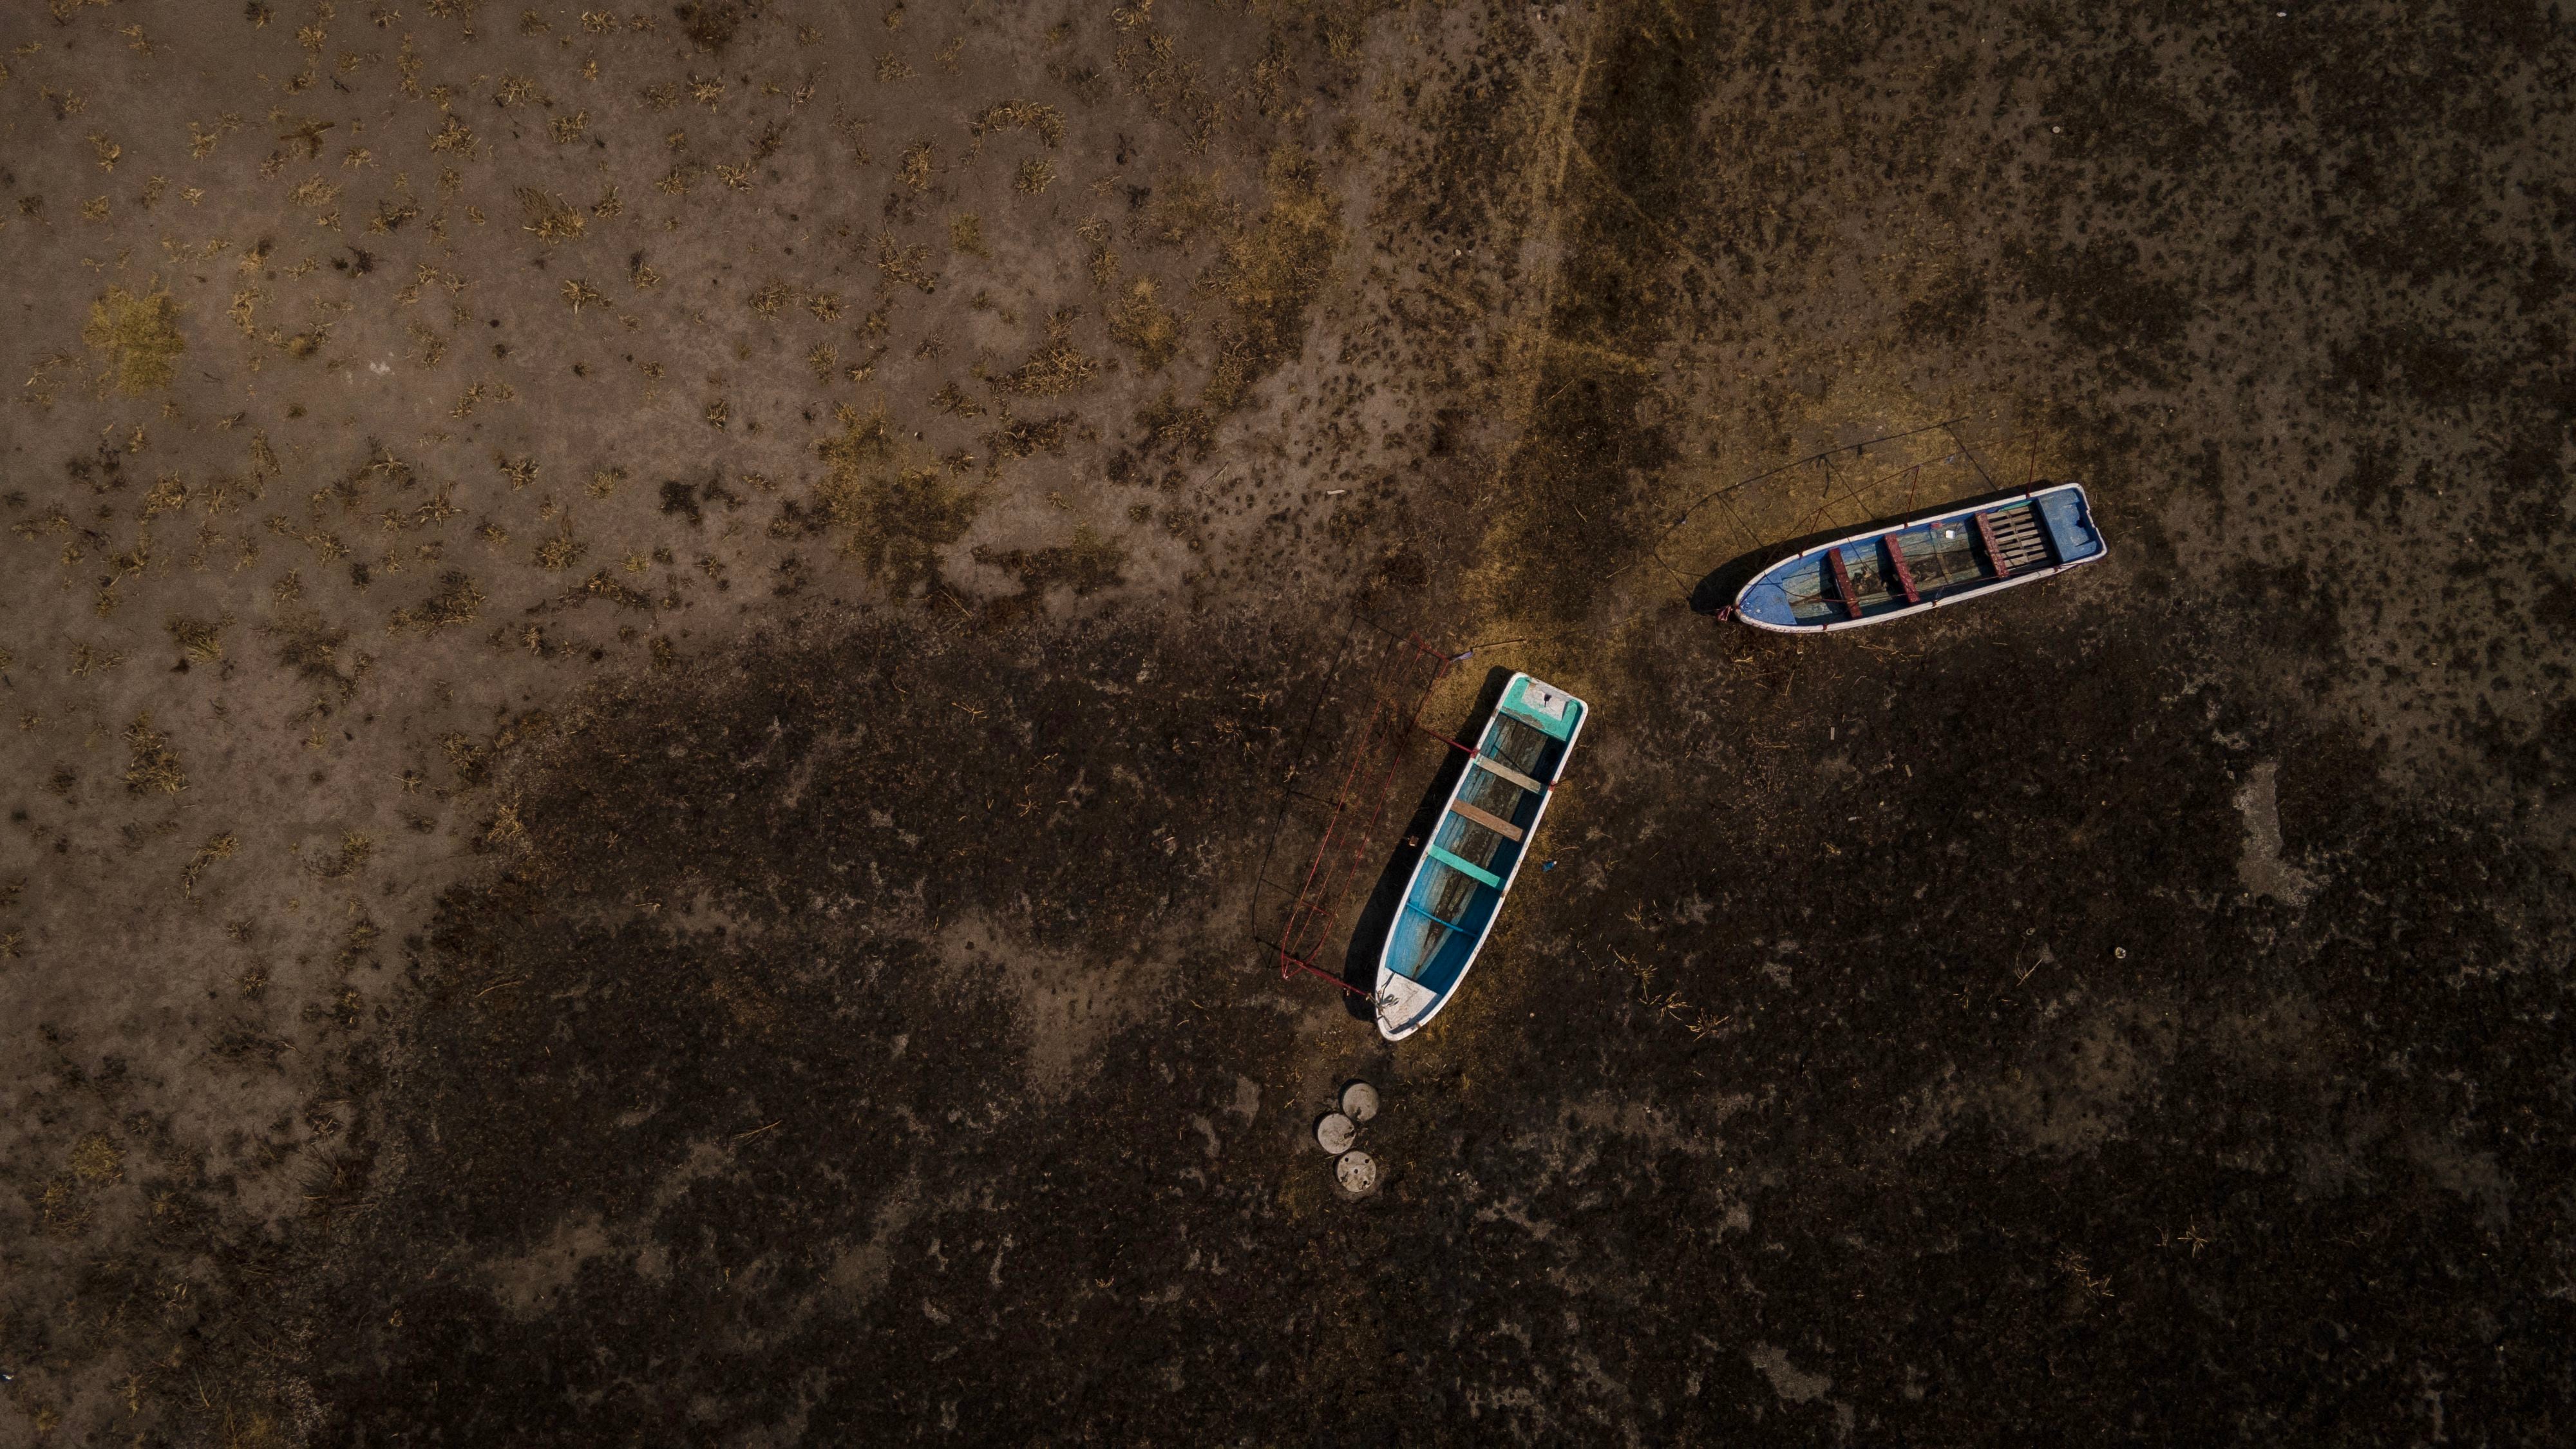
[1734,482,2110,634]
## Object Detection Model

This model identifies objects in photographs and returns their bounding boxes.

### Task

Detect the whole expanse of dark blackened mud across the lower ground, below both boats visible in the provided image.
[261,585,2576,1444]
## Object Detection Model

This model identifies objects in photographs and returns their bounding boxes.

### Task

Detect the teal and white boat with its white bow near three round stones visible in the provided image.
[1378,673,1589,1041]
